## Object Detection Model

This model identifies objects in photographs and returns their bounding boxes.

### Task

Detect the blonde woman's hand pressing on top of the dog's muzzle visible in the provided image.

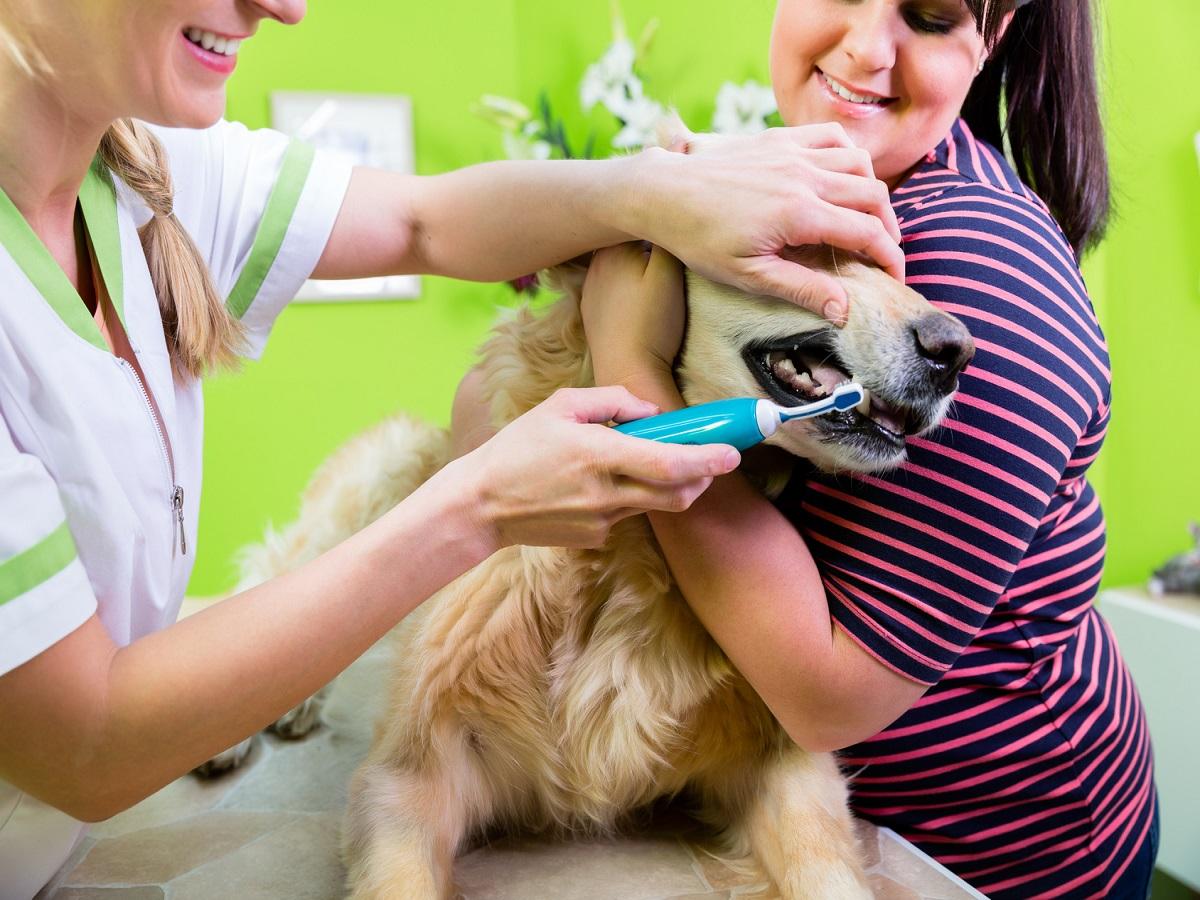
[629,124,904,322]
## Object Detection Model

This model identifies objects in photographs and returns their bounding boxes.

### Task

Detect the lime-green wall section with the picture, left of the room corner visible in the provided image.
[190,0,516,595]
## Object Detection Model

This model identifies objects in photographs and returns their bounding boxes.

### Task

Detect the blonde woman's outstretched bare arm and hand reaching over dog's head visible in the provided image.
[316,125,904,319]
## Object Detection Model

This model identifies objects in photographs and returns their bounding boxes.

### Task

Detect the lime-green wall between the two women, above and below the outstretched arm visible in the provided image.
[190,0,774,595]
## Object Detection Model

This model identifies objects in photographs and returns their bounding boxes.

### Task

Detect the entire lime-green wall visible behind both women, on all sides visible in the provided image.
[191,0,1200,595]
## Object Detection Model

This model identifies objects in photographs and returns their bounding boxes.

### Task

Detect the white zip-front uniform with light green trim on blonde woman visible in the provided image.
[0,122,350,900]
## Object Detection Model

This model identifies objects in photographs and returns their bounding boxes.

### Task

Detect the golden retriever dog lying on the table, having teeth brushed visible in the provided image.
[223,236,973,900]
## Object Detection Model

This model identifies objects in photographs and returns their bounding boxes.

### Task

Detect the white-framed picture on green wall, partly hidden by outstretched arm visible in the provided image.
[270,91,421,301]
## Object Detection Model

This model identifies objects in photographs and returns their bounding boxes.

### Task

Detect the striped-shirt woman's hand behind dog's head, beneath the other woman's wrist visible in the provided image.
[580,244,686,401]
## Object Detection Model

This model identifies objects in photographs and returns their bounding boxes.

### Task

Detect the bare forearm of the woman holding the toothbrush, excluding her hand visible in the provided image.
[69,468,490,820]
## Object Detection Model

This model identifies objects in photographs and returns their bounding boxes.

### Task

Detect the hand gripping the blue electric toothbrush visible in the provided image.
[444,388,740,550]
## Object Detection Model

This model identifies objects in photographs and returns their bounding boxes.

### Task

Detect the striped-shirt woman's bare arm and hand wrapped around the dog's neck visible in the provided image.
[582,246,925,751]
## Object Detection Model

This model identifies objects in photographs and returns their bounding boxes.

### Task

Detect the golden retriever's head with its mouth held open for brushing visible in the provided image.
[678,247,974,472]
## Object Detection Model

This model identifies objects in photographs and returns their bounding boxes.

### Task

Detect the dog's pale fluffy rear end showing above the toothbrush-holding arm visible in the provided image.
[235,415,450,593]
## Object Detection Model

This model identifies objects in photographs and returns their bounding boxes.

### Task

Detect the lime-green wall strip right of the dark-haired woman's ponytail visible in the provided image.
[1100,0,1200,584]
